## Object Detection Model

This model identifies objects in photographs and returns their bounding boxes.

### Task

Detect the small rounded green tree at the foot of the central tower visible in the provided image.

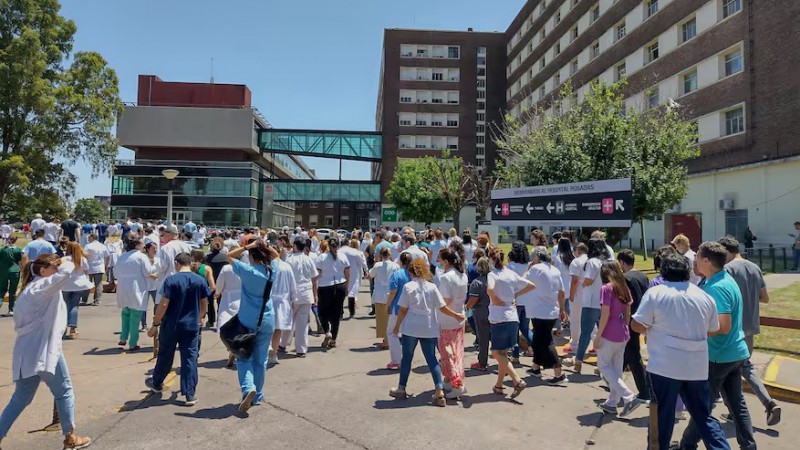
[386,158,448,224]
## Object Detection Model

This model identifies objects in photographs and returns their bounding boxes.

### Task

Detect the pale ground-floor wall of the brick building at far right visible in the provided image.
[624,157,800,247]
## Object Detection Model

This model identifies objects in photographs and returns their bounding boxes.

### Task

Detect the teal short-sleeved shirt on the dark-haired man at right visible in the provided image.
[703,270,750,363]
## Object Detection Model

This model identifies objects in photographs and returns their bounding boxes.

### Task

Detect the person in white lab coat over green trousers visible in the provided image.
[114,239,156,352]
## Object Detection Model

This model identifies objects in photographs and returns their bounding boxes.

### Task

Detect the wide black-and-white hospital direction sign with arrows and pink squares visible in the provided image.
[491,178,633,227]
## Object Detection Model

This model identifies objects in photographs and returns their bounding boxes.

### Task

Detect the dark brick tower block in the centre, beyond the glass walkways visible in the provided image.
[373,29,506,229]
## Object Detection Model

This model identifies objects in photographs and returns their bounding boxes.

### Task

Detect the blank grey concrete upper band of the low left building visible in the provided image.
[117,106,255,151]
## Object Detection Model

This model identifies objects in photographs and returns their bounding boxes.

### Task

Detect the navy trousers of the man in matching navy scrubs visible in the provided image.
[153,328,200,397]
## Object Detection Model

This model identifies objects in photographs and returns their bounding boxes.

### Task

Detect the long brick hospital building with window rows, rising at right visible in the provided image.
[506,0,800,245]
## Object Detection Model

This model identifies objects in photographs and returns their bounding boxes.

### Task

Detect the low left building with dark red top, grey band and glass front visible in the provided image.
[111,75,314,226]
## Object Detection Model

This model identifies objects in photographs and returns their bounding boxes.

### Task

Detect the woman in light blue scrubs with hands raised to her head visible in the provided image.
[226,238,280,413]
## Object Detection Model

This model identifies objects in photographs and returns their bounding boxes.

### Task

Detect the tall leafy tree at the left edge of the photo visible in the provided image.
[0,0,122,218]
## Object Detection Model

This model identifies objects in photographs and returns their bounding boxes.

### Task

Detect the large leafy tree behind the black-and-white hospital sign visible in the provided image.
[496,81,700,243]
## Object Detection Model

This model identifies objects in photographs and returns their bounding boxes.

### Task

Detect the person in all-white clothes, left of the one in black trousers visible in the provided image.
[278,238,319,358]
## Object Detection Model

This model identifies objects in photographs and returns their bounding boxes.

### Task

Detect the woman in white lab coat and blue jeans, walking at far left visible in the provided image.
[0,254,92,449]
